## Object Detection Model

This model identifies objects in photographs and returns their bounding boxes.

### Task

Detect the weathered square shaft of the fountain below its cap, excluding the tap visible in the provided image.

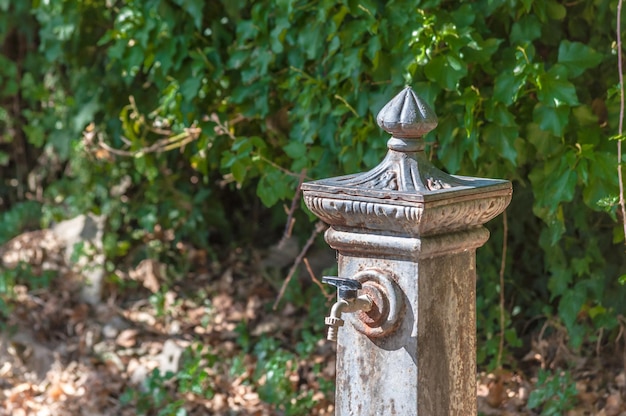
[327,231,488,416]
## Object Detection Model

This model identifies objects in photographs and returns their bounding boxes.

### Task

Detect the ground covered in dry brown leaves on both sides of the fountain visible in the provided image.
[0,229,626,416]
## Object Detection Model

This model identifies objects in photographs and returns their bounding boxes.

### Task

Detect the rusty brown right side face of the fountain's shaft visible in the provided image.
[417,251,477,416]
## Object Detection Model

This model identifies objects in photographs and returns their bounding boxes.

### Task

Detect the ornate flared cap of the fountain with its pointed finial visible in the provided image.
[302,87,512,236]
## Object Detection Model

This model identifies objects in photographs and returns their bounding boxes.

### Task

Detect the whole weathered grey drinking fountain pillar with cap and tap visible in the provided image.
[302,87,512,416]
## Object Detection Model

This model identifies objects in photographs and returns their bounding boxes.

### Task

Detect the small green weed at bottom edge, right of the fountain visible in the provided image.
[528,369,578,416]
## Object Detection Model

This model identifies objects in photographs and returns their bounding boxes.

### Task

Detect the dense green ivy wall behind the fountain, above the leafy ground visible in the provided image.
[0,0,626,376]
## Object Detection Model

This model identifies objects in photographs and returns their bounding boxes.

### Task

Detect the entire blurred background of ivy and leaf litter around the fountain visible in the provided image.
[0,0,626,415]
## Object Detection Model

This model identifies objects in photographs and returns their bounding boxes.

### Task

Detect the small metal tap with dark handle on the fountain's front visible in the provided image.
[322,276,373,341]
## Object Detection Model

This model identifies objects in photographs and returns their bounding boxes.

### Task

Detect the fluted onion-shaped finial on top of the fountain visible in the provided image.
[376,86,437,139]
